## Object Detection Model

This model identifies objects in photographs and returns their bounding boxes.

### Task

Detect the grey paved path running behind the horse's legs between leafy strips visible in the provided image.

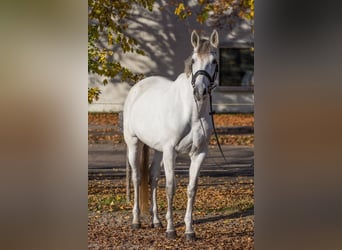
[88,144,254,179]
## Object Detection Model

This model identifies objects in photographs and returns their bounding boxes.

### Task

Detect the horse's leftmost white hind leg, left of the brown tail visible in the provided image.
[126,137,141,229]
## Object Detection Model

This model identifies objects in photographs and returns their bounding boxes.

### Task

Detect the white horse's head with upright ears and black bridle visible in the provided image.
[190,30,219,100]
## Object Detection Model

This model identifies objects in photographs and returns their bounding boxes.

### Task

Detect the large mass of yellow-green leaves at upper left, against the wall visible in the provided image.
[88,0,155,103]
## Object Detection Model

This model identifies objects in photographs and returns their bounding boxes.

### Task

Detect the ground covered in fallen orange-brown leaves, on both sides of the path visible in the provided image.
[88,114,254,249]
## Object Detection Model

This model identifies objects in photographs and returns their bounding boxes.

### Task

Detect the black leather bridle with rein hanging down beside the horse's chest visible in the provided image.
[191,64,228,163]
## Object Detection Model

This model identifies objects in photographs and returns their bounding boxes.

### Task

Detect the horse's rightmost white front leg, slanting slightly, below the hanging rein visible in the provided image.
[184,150,207,240]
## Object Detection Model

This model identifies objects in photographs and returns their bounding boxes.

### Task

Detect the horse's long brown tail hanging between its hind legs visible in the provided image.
[139,144,149,214]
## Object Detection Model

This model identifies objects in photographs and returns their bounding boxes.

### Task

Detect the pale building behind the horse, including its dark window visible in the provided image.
[88,1,254,113]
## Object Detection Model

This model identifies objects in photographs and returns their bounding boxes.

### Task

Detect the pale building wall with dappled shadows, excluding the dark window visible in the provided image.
[88,1,254,112]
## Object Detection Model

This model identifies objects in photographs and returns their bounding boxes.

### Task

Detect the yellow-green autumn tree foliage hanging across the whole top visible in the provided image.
[88,0,254,103]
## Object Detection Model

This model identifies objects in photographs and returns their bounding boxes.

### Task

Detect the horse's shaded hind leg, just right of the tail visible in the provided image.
[150,151,163,228]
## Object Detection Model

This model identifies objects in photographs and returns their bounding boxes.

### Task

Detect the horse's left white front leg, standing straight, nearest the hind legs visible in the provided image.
[163,148,177,239]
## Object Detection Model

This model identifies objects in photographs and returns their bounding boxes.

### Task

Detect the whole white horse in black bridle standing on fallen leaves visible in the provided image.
[124,30,219,240]
